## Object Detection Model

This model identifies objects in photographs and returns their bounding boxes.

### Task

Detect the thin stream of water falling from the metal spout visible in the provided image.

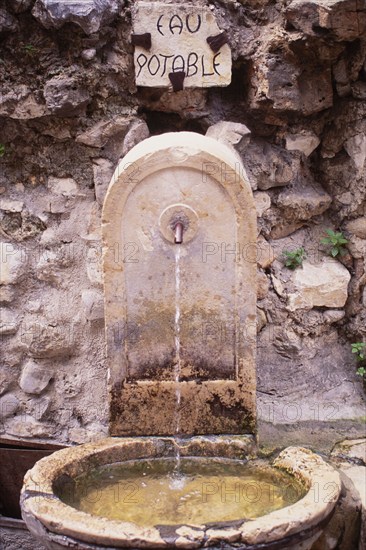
[174,246,181,473]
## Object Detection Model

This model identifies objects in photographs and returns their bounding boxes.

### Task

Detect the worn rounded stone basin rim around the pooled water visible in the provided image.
[21,436,341,550]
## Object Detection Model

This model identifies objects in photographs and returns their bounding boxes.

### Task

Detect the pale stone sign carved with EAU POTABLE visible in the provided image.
[133,1,231,89]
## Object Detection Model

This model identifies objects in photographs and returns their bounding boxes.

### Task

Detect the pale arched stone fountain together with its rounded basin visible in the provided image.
[21,132,340,550]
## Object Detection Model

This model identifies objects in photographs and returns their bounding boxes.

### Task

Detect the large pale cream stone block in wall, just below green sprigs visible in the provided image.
[288,257,351,311]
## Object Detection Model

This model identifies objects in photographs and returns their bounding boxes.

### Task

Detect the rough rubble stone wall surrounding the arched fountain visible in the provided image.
[0,0,366,446]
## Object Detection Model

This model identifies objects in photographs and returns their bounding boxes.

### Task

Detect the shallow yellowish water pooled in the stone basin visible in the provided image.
[58,458,306,527]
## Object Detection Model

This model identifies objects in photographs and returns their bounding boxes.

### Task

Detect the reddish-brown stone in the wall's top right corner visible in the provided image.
[286,0,366,41]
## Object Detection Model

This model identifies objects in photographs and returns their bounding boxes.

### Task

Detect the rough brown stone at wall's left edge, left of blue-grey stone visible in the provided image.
[0,84,49,120]
